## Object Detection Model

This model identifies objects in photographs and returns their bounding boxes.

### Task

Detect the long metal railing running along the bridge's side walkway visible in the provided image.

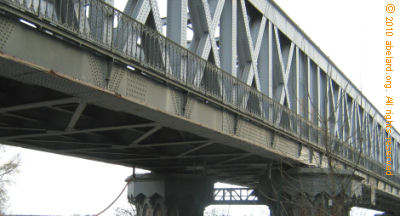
[0,0,400,183]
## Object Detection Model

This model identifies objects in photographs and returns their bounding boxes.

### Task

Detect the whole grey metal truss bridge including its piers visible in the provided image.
[0,0,400,215]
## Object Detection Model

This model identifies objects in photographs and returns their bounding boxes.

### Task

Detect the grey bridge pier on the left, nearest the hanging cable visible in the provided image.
[128,174,214,216]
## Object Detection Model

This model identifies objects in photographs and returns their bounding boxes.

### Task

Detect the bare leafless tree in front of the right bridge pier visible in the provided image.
[262,80,370,216]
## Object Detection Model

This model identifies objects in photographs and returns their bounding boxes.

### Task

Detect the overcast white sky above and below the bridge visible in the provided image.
[2,0,400,215]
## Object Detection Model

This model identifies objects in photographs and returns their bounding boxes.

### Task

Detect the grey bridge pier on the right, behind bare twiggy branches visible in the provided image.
[258,168,362,216]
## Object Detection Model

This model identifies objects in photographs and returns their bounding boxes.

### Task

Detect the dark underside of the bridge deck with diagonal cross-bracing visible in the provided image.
[0,55,278,185]
